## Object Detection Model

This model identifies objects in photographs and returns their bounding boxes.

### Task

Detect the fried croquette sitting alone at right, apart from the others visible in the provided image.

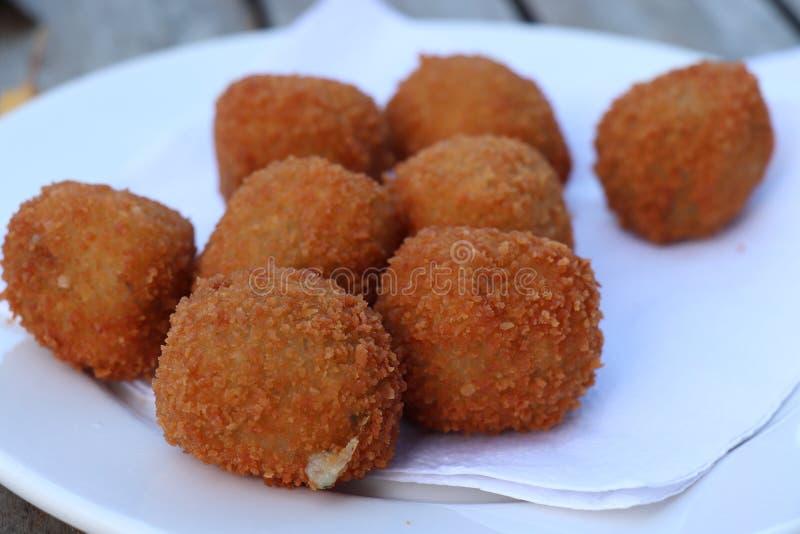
[595,63,773,243]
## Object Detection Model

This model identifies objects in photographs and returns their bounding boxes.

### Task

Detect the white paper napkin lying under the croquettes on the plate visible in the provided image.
[111,0,800,509]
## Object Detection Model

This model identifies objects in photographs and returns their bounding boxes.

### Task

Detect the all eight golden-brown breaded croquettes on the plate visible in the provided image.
[3,52,773,489]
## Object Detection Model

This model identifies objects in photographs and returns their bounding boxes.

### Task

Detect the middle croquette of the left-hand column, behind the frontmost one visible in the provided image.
[197,157,403,295]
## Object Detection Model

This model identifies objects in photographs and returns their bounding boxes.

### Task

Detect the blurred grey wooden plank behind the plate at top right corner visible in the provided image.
[524,0,798,58]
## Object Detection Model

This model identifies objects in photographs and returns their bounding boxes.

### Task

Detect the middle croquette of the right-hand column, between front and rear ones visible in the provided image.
[387,135,573,247]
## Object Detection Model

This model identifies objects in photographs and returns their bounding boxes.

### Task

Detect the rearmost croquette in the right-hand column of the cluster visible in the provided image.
[386,55,571,182]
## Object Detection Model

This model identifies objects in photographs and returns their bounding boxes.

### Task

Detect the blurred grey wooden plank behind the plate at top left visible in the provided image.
[3,0,254,88]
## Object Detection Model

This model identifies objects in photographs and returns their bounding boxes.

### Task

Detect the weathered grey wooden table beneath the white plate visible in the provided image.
[0,0,800,533]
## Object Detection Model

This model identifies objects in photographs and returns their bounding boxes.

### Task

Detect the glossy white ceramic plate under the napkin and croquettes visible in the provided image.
[0,4,800,532]
